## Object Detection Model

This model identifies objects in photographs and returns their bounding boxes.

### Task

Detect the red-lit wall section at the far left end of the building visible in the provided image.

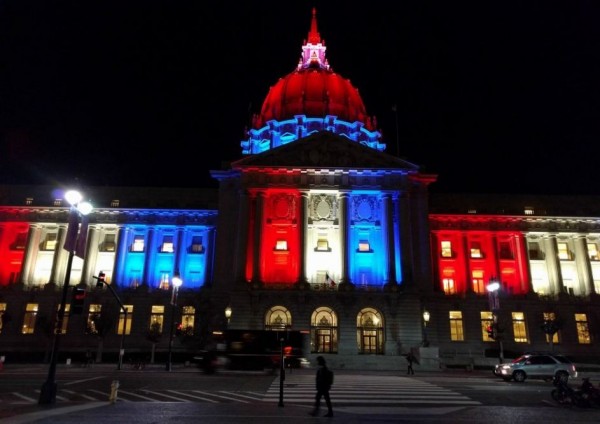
[0,222,29,285]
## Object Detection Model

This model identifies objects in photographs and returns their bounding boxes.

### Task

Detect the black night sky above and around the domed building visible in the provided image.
[0,0,600,194]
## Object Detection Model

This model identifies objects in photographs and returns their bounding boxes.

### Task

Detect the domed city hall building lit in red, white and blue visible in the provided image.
[0,10,600,369]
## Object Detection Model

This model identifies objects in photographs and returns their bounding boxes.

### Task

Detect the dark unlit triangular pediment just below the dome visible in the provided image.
[232,131,419,171]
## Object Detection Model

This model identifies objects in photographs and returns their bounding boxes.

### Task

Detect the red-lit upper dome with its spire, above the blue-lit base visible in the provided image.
[252,9,376,131]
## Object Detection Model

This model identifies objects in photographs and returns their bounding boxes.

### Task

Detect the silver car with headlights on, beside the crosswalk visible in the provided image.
[494,353,577,383]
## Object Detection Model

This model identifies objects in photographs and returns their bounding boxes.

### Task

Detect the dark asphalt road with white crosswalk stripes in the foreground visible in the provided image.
[0,365,600,424]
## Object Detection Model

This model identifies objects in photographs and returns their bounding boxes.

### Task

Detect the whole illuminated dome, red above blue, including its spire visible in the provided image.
[241,8,386,154]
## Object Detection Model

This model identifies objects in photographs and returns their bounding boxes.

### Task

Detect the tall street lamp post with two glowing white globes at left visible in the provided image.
[38,190,93,405]
